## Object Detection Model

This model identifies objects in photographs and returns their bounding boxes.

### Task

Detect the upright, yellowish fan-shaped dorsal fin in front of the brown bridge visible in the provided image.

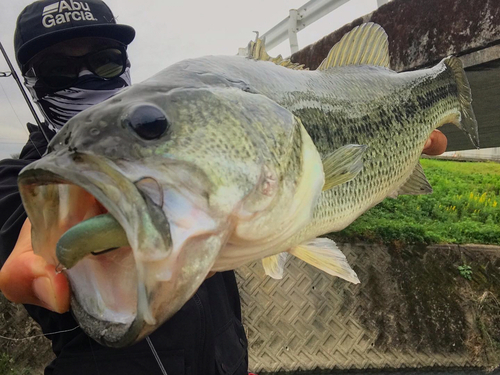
[318,22,389,70]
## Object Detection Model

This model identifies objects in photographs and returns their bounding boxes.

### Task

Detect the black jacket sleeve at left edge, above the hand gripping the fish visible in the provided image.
[0,124,47,266]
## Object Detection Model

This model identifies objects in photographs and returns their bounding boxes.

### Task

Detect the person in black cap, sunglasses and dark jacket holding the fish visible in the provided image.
[0,0,247,375]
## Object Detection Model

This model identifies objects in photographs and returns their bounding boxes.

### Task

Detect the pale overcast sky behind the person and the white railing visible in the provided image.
[0,0,377,159]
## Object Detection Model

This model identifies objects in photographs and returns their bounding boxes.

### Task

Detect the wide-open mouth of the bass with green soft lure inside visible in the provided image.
[19,151,171,347]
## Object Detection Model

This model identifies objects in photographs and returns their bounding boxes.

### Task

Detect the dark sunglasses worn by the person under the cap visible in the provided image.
[26,46,127,90]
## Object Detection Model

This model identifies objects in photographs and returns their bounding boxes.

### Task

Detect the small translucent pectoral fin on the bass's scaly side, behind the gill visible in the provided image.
[323,145,368,191]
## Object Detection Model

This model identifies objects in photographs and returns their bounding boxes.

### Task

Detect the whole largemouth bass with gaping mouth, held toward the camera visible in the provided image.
[19,24,478,346]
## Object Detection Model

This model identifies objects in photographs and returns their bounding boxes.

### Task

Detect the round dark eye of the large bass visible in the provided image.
[124,104,169,140]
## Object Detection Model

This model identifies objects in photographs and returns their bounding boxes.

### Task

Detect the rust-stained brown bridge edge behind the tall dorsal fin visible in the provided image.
[292,0,500,71]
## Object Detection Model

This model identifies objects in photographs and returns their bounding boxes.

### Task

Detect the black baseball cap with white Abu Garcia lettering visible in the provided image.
[14,0,135,71]
